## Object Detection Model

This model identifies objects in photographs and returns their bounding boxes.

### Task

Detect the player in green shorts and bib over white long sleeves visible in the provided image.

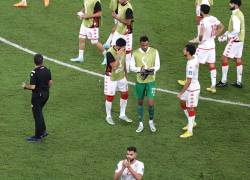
[130,36,160,133]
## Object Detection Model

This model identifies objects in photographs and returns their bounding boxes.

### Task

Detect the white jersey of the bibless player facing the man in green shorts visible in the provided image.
[186,55,200,91]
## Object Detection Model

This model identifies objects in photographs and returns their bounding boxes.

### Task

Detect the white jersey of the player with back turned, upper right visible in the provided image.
[199,16,220,49]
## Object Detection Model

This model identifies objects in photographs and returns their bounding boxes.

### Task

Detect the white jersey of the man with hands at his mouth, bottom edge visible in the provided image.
[115,160,144,180]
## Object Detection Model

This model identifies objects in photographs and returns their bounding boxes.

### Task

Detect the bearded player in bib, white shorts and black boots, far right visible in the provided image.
[216,0,245,88]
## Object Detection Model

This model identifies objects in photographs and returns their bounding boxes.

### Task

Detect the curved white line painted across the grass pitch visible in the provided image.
[0,37,250,108]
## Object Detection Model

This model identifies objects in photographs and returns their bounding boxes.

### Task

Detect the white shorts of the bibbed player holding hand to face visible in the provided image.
[104,75,128,96]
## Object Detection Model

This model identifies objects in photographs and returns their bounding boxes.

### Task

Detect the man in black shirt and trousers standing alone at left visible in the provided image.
[22,54,52,142]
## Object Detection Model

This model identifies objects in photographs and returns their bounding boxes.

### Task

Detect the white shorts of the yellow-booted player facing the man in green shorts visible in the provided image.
[180,89,200,108]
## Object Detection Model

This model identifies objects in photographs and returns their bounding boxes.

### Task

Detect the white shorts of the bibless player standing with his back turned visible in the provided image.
[196,48,216,64]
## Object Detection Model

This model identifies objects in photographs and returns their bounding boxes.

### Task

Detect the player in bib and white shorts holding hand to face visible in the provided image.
[104,38,132,125]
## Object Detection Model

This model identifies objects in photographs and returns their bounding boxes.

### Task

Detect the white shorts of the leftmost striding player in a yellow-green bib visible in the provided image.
[79,24,99,40]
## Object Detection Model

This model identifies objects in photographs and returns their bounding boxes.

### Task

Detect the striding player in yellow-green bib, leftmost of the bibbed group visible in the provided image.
[70,0,106,63]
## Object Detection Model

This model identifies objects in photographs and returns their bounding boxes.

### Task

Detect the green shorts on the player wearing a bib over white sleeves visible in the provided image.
[135,81,156,99]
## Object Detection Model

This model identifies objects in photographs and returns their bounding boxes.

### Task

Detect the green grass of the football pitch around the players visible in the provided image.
[0,0,250,180]
